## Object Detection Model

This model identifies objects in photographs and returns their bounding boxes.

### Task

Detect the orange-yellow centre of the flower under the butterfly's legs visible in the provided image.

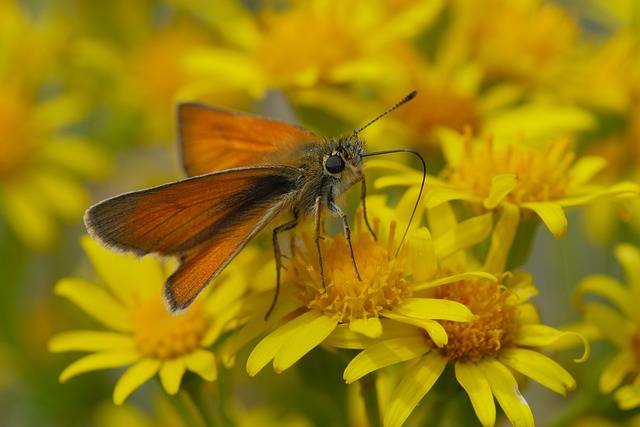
[292,219,409,322]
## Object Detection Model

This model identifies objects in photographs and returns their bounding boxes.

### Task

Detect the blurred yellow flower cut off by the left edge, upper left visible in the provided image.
[0,2,107,249]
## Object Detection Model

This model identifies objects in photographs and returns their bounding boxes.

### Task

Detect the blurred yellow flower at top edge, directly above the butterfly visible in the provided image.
[175,0,444,98]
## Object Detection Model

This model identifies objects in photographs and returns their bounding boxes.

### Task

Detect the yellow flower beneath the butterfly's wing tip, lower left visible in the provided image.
[49,236,244,405]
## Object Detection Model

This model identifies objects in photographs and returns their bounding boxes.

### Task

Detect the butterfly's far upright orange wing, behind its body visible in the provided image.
[178,103,319,176]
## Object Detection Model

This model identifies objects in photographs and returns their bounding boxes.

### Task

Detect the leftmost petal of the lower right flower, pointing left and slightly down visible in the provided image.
[343,337,430,384]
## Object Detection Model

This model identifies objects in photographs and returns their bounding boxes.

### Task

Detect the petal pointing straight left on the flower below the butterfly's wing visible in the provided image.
[49,331,135,353]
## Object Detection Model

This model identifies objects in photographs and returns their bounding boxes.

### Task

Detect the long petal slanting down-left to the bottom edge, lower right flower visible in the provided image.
[384,352,448,427]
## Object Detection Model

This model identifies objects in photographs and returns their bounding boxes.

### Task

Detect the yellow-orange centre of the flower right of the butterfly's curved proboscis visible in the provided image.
[445,134,575,204]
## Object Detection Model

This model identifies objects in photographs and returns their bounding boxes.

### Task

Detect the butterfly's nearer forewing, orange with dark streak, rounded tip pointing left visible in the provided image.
[85,166,299,255]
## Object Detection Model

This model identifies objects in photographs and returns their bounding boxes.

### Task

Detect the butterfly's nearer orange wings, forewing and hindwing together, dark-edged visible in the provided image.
[85,166,300,311]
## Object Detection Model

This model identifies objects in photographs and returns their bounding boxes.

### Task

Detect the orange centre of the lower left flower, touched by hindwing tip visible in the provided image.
[132,297,207,360]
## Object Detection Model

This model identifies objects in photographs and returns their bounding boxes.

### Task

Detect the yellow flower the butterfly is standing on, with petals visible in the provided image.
[222,198,495,375]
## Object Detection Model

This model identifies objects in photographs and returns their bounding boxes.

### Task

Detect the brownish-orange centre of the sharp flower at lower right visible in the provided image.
[434,281,518,362]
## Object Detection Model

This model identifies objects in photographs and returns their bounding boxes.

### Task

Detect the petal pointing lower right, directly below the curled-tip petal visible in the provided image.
[498,348,576,396]
